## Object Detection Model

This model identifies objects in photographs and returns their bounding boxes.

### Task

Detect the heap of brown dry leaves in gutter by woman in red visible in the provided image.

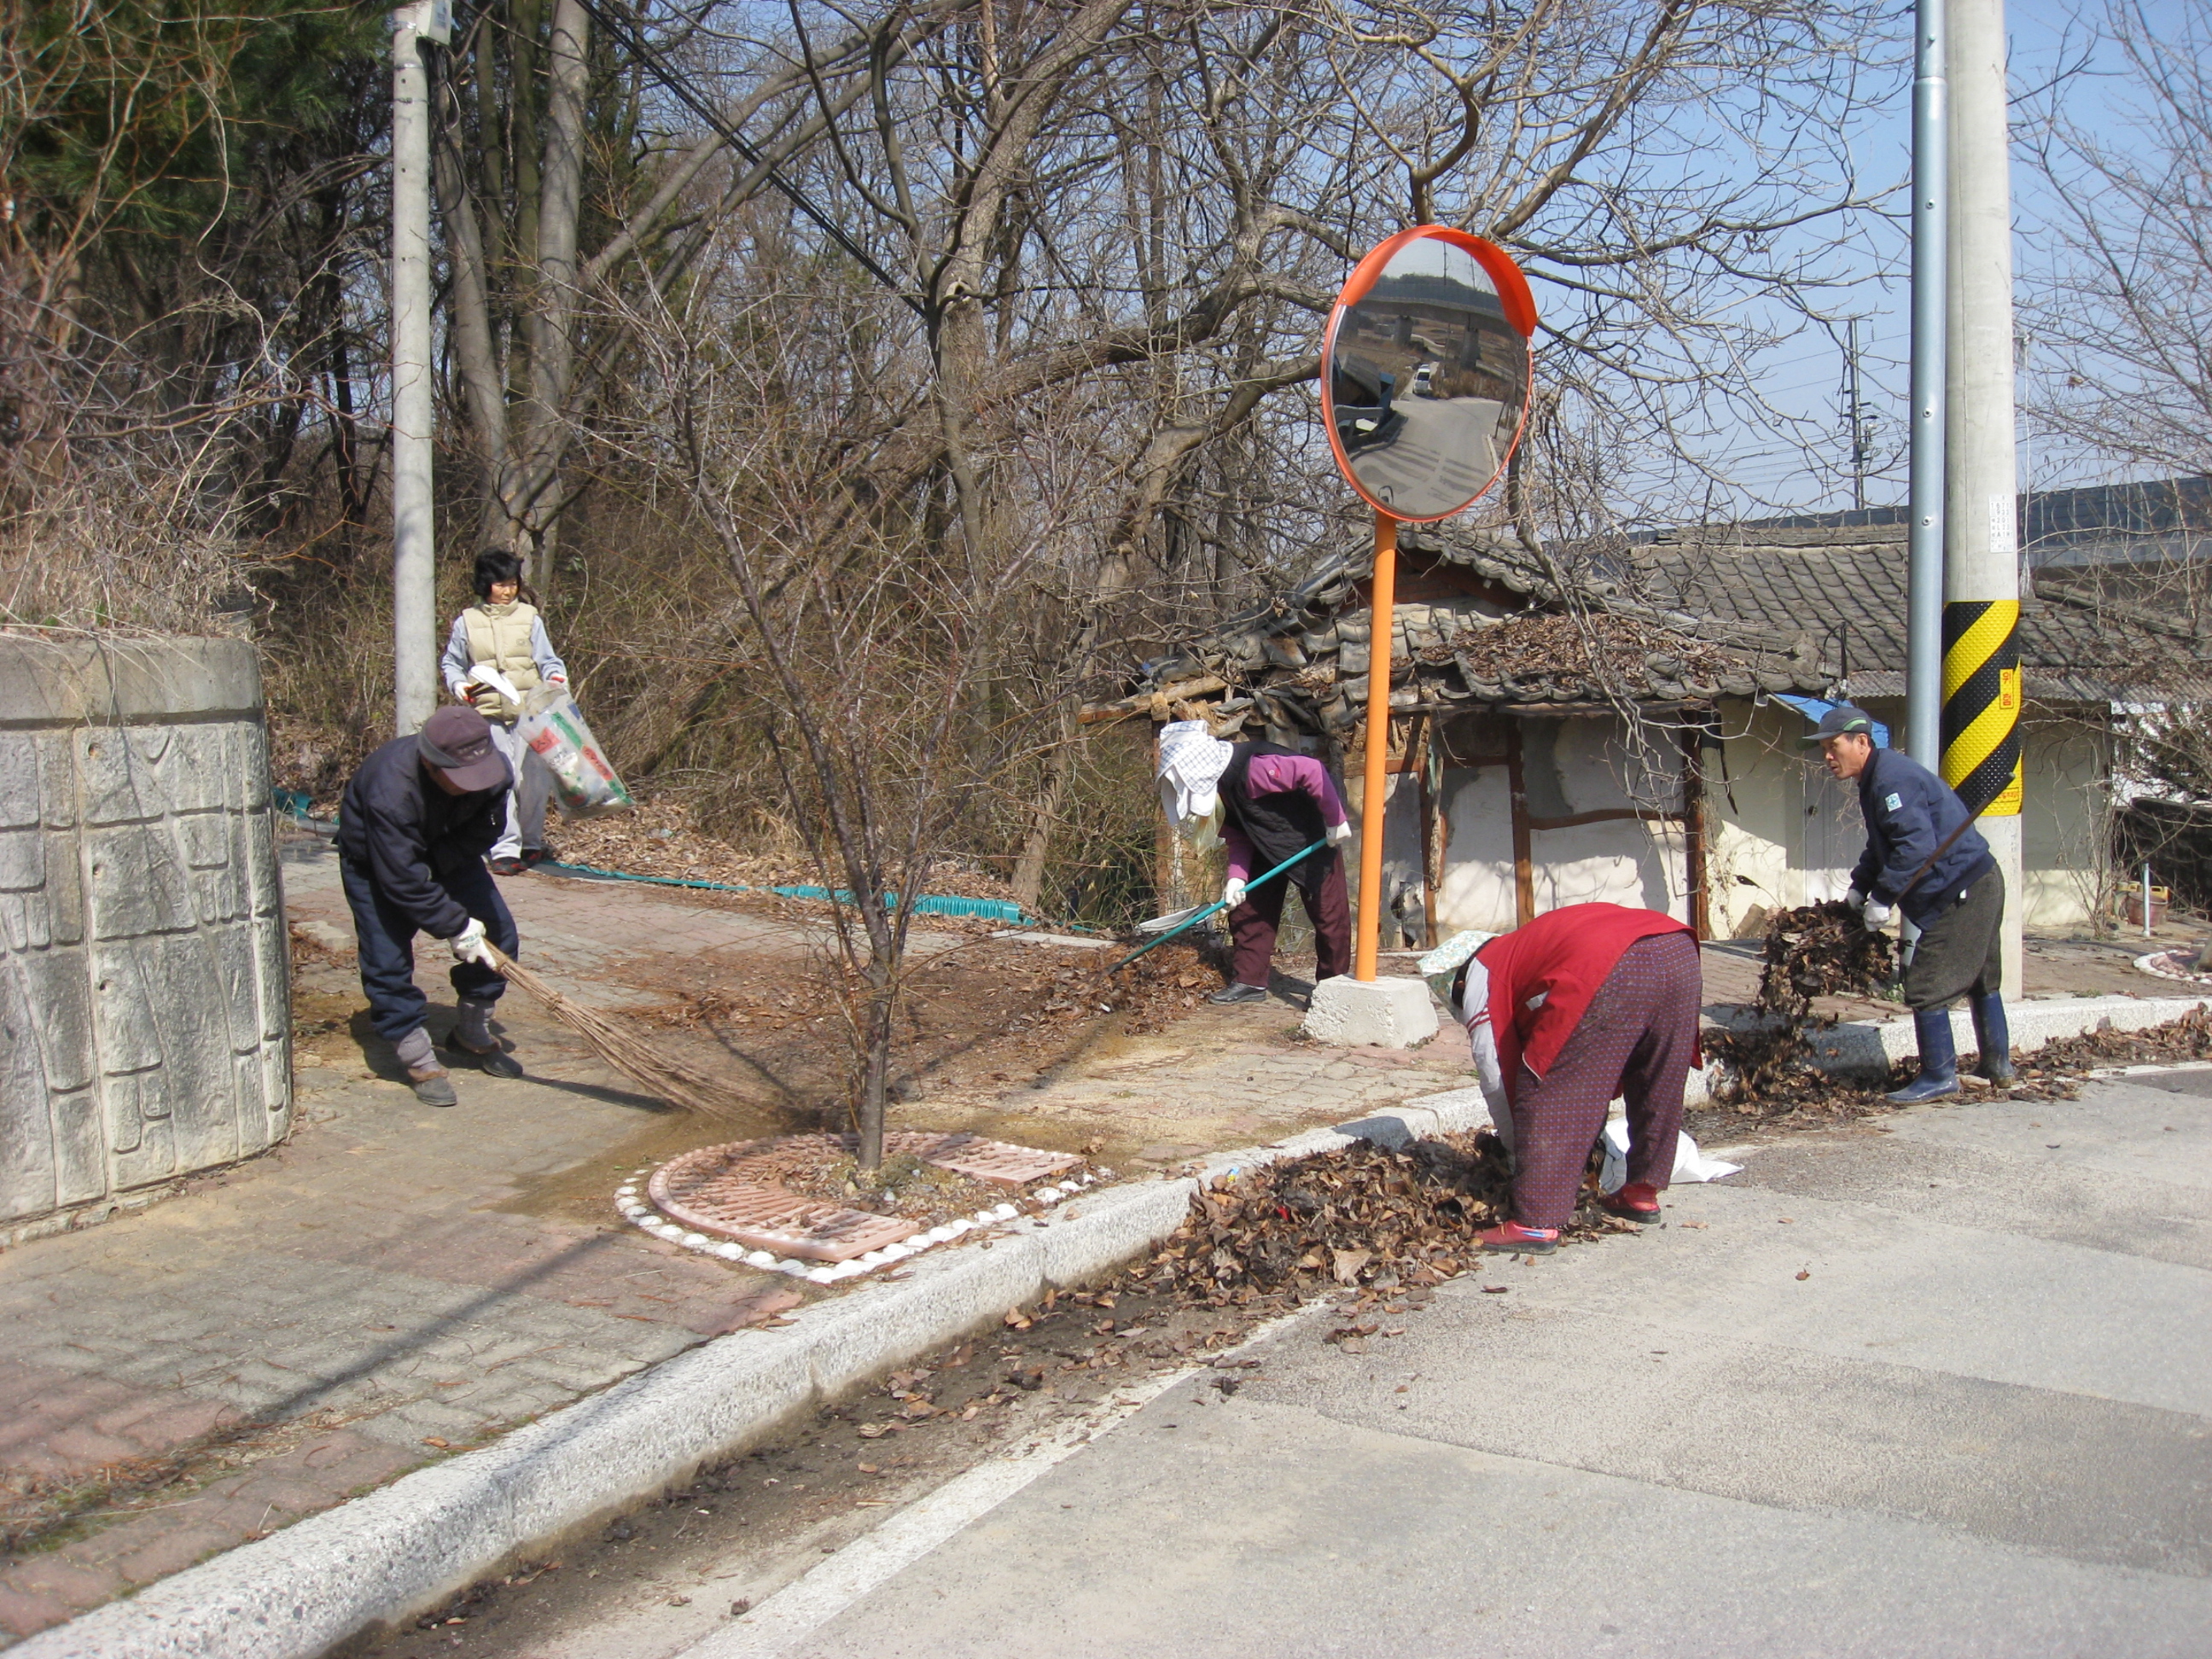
[1126,1131,1628,1305]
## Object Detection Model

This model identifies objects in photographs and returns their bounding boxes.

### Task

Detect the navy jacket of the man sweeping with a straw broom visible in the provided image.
[339,736,513,938]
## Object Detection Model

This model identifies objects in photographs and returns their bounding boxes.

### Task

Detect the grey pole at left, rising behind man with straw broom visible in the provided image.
[392,7,438,736]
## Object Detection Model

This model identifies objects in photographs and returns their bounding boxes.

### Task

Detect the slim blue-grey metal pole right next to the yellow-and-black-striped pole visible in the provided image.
[1905,0,1949,767]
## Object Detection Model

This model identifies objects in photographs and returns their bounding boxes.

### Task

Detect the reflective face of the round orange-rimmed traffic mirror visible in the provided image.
[1327,236,1528,518]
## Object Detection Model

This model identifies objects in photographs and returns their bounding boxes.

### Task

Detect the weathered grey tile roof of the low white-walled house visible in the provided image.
[1099,524,2212,741]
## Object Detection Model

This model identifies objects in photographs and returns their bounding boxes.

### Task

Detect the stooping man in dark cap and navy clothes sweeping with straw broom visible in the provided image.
[339,707,522,1106]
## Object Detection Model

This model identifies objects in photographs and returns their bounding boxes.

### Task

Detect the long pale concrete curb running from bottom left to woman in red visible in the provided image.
[9,1088,1488,1659]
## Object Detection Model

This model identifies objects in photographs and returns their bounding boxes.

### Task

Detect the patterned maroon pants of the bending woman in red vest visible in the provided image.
[1513,934,1705,1228]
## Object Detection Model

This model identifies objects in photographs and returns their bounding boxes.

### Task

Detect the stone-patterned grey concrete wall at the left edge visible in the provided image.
[0,635,292,1241]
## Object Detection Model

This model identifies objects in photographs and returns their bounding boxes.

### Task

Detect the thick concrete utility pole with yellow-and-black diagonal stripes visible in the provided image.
[1942,0,2026,995]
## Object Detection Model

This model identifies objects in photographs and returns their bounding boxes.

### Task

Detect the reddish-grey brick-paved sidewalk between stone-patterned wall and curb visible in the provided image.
[0,841,1464,1637]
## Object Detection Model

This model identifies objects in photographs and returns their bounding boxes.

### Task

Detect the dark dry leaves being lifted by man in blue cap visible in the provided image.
[1705,903,1895,1110]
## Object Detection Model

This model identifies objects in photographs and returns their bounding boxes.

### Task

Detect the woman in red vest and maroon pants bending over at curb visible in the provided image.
[1423,905,1703,1256]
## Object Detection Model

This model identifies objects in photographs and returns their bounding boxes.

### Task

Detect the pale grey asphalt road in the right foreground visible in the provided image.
[690,1073,2212,1659]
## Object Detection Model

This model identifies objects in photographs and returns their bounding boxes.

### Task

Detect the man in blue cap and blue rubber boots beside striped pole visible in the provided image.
[1805,703,2013,1106]
